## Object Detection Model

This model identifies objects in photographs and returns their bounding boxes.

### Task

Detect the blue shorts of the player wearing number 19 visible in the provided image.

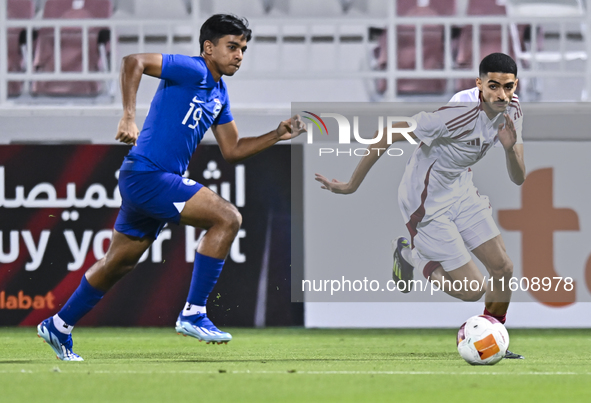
[115,170,203,239]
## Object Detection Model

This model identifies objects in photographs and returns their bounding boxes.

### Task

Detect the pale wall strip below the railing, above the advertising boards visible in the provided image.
[0,102,591,144]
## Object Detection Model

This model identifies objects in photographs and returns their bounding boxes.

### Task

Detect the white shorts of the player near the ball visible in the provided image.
[412,188,500,271]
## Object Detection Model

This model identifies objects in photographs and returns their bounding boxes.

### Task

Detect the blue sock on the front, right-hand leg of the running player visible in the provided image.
[187,252,224,306]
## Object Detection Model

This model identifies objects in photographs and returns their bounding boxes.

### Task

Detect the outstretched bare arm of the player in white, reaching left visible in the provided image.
[316,122,417,194]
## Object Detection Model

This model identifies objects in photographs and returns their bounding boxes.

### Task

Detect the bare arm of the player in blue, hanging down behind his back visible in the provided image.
[115,53,162,145]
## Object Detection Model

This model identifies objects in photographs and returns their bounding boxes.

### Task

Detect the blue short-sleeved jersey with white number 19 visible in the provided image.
[121,54,234,175]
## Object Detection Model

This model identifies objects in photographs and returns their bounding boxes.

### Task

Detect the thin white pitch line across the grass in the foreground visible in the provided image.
[0,366,591,376]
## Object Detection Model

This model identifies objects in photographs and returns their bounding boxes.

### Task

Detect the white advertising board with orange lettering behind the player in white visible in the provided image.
[304,140,591,328]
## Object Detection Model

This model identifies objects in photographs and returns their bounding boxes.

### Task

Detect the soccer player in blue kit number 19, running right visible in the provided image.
[37,14,305,361]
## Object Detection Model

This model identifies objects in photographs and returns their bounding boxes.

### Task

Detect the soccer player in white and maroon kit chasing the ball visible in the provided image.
[316,53,525,358]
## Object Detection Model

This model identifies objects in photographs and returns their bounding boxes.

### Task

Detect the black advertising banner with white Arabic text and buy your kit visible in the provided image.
[0,145,302,326]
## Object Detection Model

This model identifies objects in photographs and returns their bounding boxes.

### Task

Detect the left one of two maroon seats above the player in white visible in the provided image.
[375,0,448,95]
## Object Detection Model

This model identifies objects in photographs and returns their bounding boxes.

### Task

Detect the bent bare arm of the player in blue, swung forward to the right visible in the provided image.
[211,115,306,164]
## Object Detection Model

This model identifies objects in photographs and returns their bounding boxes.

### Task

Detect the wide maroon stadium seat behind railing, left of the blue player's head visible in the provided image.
[31,0,112,96]
